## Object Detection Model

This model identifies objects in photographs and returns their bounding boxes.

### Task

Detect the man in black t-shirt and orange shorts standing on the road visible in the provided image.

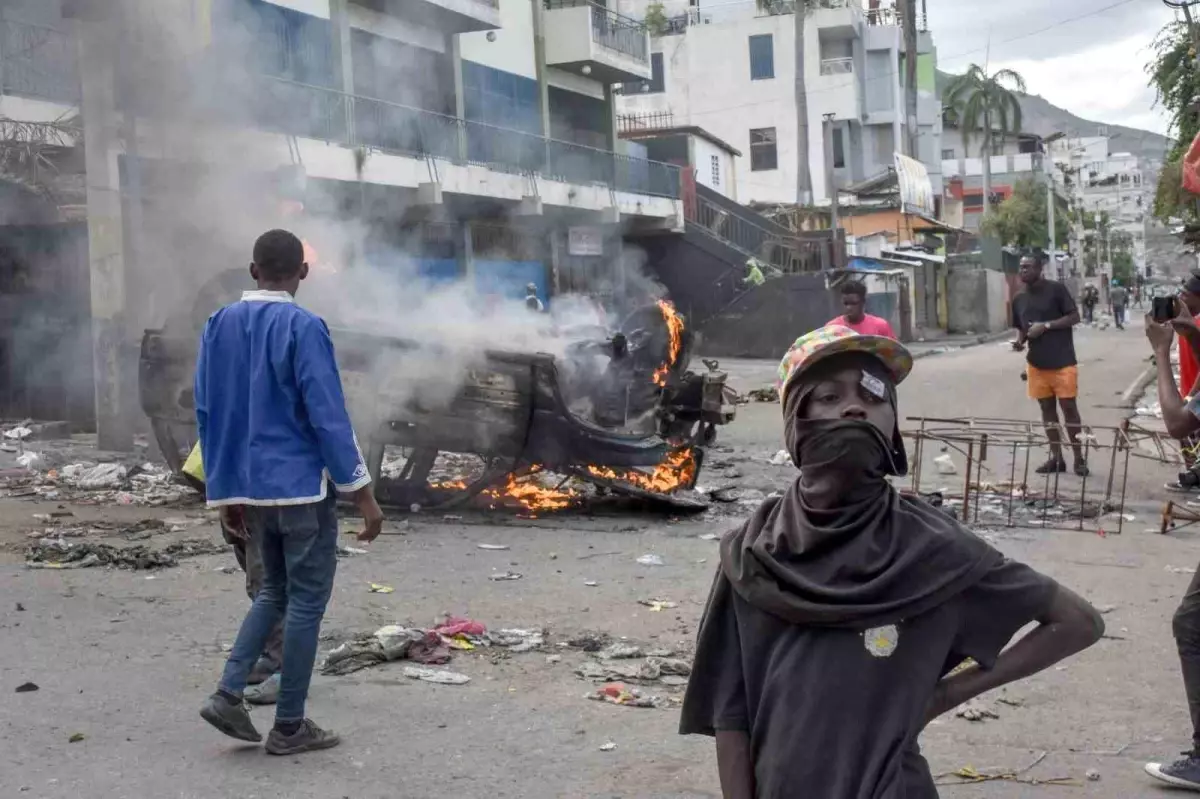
[1013,256,1087,477]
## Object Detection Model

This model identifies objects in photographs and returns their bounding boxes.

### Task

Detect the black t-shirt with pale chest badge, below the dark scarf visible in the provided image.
[680,560,1057,799]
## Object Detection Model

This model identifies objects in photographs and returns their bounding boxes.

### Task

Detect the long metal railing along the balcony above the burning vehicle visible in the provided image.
[250,77,679,199]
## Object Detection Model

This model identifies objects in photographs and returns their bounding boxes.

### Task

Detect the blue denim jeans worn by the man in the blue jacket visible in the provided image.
[220,487,337,721]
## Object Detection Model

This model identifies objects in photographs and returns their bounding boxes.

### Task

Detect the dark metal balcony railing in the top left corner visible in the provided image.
[0,20,79,104]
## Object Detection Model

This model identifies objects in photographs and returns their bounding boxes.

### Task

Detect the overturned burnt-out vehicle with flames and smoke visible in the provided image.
[139,267,734,512]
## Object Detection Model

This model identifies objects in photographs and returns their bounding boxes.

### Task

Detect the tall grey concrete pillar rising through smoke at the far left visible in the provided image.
[74,20,137,451]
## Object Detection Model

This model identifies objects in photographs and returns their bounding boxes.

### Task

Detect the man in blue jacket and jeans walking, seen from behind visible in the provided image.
[196,230,383,755]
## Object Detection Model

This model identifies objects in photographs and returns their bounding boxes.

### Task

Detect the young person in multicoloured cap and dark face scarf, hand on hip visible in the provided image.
[680,325,1104,799]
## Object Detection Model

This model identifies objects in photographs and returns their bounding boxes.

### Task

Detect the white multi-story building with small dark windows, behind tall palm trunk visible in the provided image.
[618,0,942,204]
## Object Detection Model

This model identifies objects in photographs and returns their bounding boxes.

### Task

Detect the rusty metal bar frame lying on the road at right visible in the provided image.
[901,416,1180,535]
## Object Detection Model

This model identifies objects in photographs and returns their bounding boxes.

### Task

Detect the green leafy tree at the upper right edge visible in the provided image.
[1146,22,1200,222]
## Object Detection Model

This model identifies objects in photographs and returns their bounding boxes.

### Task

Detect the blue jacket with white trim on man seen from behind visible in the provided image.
[196,292,371,506]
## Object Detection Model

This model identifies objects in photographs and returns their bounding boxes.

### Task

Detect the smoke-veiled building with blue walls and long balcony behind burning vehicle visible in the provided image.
[0,0,684,449]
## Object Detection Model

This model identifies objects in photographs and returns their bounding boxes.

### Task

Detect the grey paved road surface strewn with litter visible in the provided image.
[0,319,1200,799]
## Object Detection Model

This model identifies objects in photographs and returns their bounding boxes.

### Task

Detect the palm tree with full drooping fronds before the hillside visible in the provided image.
[943,64,1026,216]
